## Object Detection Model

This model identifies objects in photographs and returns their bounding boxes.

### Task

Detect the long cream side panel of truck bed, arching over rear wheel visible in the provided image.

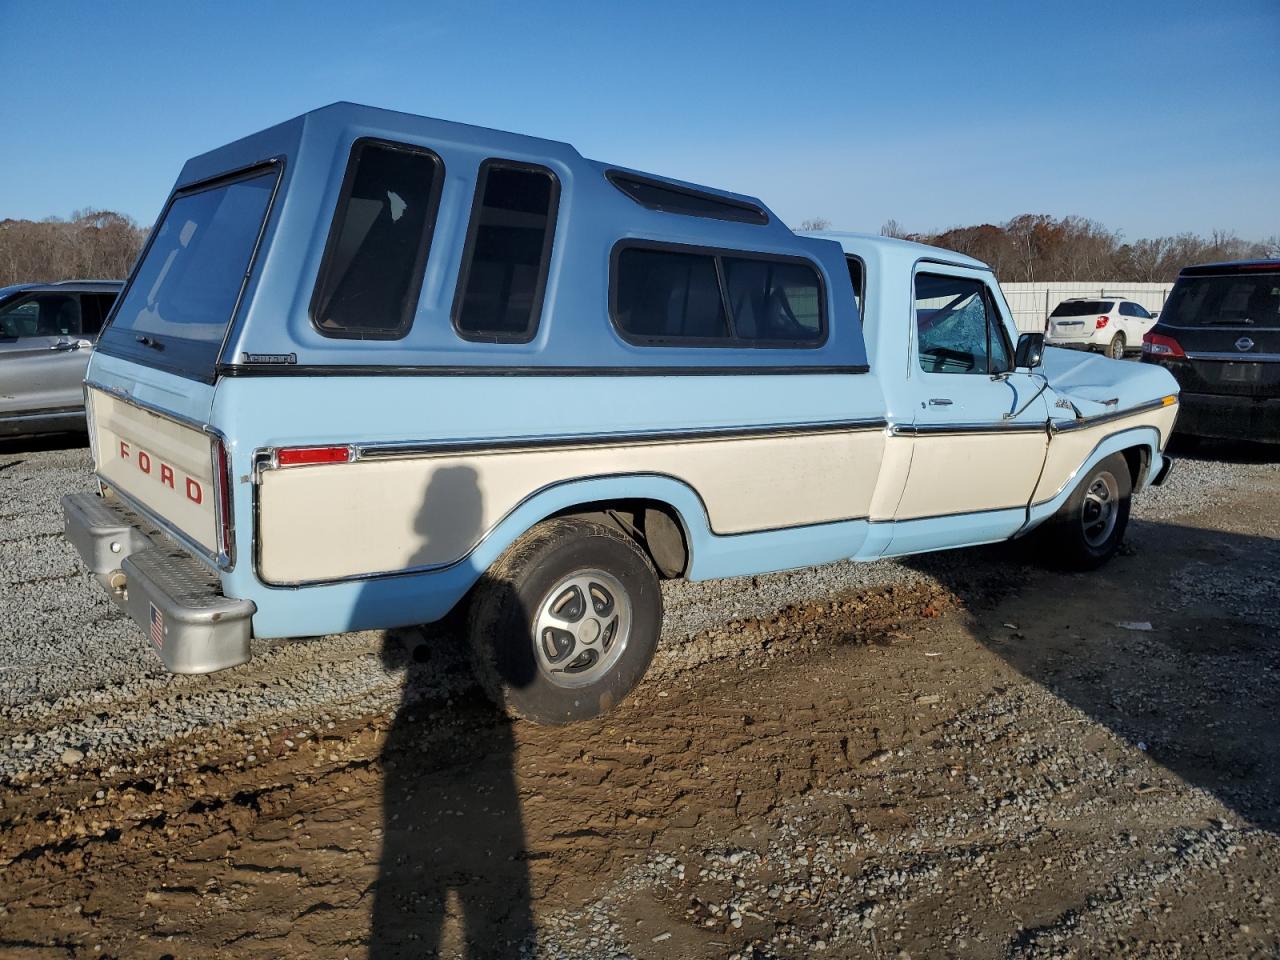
[259,430,884,584]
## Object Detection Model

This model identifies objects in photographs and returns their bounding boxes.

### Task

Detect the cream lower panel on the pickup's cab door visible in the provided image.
[896,433,1048,520]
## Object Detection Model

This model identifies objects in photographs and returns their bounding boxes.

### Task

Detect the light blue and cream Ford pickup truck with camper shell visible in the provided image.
[64,104,1178,723]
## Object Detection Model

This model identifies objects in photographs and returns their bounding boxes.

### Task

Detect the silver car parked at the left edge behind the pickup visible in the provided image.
[0,280,124,436]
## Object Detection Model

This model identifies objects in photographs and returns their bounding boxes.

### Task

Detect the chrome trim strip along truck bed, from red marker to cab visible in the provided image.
[350,419,888,460]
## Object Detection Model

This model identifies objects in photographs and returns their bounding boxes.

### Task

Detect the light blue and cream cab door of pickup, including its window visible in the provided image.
[893,271,1048,553]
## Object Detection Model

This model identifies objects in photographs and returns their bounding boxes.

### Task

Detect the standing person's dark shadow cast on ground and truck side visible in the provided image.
[369,466,534,960]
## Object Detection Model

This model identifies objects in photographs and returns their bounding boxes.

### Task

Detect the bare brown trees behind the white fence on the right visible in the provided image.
[799,214,1280,283]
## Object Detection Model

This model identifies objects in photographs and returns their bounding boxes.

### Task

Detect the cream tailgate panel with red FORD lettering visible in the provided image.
[90,390,218,553]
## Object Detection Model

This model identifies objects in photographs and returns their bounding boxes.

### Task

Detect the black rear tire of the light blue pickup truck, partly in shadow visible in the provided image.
[467,517,662,724]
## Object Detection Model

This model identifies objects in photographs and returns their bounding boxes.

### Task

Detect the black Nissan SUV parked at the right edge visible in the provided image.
[1142,260,1280,443]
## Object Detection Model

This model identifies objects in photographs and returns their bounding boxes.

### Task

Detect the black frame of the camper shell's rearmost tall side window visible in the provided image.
[307,137,447,340]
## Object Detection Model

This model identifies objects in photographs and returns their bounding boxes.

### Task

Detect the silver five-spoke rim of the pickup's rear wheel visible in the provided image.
[532,570,631,687]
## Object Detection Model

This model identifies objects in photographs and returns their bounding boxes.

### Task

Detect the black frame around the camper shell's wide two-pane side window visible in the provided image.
[608,237,831,351]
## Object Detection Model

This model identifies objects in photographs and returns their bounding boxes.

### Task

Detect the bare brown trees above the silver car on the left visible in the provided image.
[0,216,147,287]
